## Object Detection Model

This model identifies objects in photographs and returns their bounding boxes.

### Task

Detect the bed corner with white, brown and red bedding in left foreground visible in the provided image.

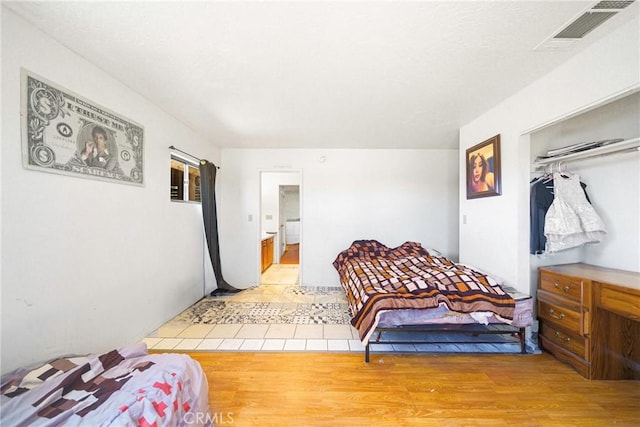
[0,343,212,426]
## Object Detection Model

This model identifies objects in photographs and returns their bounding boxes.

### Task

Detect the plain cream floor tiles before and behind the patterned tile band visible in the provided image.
[143,264,364,352]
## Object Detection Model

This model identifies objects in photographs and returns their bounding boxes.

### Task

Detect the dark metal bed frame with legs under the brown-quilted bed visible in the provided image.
[364,323,527,363]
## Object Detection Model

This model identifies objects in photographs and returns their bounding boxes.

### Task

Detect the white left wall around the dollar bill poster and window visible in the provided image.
[0,8,219,372]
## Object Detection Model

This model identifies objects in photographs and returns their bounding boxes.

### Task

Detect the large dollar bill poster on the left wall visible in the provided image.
[21,69,144,186]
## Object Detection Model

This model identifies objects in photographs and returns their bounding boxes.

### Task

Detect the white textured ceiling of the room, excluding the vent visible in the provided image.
[3,0,638,148]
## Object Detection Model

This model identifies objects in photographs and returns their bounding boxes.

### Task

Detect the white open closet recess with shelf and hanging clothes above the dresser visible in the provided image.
[528,90,640,292]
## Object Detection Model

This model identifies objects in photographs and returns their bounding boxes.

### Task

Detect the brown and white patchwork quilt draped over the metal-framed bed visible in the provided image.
[333,240,515,344]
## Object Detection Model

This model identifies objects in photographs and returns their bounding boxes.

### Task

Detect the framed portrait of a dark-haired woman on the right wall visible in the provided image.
[465,134,502,199]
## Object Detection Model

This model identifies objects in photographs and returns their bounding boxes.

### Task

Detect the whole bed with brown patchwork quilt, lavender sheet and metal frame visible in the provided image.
[333,240,533,362]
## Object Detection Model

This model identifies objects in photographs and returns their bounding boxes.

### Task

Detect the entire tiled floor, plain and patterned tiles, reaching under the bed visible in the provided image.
[142,264,540,354]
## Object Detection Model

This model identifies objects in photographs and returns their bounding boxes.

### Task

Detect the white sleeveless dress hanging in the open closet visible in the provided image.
[544,173,607,252]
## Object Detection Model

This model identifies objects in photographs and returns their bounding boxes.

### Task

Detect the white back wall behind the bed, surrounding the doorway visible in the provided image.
[219,149,458,288]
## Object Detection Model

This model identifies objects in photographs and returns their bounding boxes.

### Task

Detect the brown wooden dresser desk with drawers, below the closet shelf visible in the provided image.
[537,263,640,380]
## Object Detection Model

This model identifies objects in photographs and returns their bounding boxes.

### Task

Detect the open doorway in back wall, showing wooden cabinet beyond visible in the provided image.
[260,171,302,285]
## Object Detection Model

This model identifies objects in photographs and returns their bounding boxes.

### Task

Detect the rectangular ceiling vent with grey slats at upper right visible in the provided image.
[534,0,635,50]
